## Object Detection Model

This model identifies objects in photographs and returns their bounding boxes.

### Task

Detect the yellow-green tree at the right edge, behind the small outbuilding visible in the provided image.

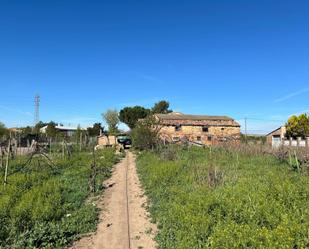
[286,113,309,137]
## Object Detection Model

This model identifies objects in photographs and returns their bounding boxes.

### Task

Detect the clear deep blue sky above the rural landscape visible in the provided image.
[0,0,309,133]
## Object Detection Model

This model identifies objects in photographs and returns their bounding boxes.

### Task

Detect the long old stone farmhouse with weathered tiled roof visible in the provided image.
[155,112,240,145]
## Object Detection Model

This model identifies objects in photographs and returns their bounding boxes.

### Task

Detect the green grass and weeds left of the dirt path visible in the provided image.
[0,149,119,248]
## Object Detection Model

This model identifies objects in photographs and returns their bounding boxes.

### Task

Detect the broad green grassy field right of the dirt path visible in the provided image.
[137,148,309,249]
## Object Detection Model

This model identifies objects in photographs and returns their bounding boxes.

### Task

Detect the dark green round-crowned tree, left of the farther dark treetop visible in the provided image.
[119,106,150,129]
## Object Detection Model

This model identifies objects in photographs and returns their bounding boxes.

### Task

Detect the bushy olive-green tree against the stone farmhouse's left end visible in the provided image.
[131,116,161,150]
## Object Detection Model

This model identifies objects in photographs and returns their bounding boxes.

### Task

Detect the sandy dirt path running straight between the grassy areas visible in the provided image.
[71,152,156,249]
